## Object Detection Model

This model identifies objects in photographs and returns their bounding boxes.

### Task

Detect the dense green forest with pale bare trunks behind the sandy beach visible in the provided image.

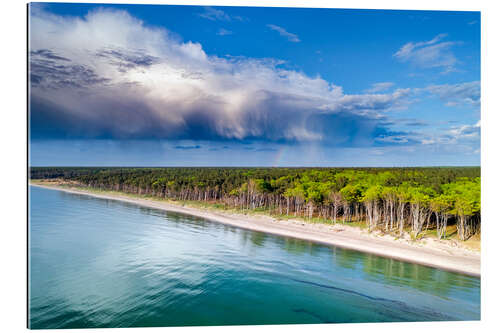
[30,167,481,240]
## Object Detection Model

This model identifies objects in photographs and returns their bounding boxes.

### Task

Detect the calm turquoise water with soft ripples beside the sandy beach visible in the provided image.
[29,187,480,328]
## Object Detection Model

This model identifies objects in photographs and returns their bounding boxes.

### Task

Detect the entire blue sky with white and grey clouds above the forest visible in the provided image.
[28,3,481,167]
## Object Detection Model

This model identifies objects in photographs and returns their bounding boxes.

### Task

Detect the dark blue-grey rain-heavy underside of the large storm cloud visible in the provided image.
[31,87,412,149]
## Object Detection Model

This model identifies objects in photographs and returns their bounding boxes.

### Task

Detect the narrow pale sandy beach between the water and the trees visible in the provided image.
[29,182,481,277]
